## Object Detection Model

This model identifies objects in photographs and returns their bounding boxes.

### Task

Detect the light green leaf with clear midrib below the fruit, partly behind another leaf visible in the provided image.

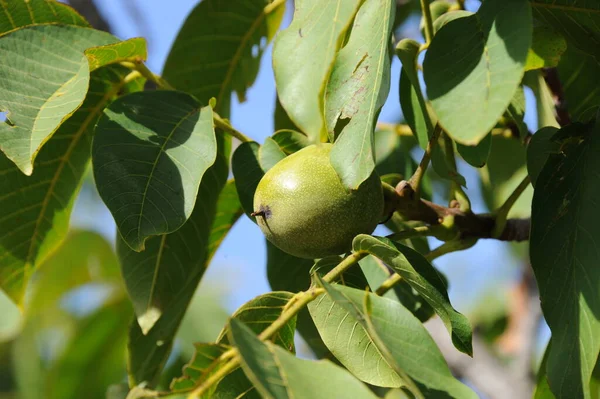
[308,280,404,388]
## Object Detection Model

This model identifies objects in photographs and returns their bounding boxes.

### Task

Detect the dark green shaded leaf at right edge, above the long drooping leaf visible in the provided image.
[558,49,600,122]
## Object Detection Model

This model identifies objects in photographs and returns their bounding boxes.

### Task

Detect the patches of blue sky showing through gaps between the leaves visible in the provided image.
[73,0,536,324]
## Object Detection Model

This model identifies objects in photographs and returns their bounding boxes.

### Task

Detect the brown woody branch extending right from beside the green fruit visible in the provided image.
[386,181,531,241]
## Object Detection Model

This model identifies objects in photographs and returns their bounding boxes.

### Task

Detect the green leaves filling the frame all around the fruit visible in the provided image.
[0,0,600,399]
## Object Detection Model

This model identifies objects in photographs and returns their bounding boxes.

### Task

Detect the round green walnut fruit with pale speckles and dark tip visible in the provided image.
[253,144,383,259]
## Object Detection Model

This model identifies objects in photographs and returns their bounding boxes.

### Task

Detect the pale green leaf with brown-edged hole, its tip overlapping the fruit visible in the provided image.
[325,0,396,189]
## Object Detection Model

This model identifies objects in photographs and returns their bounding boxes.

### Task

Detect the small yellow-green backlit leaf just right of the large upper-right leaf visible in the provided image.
[525,26,567,71]
